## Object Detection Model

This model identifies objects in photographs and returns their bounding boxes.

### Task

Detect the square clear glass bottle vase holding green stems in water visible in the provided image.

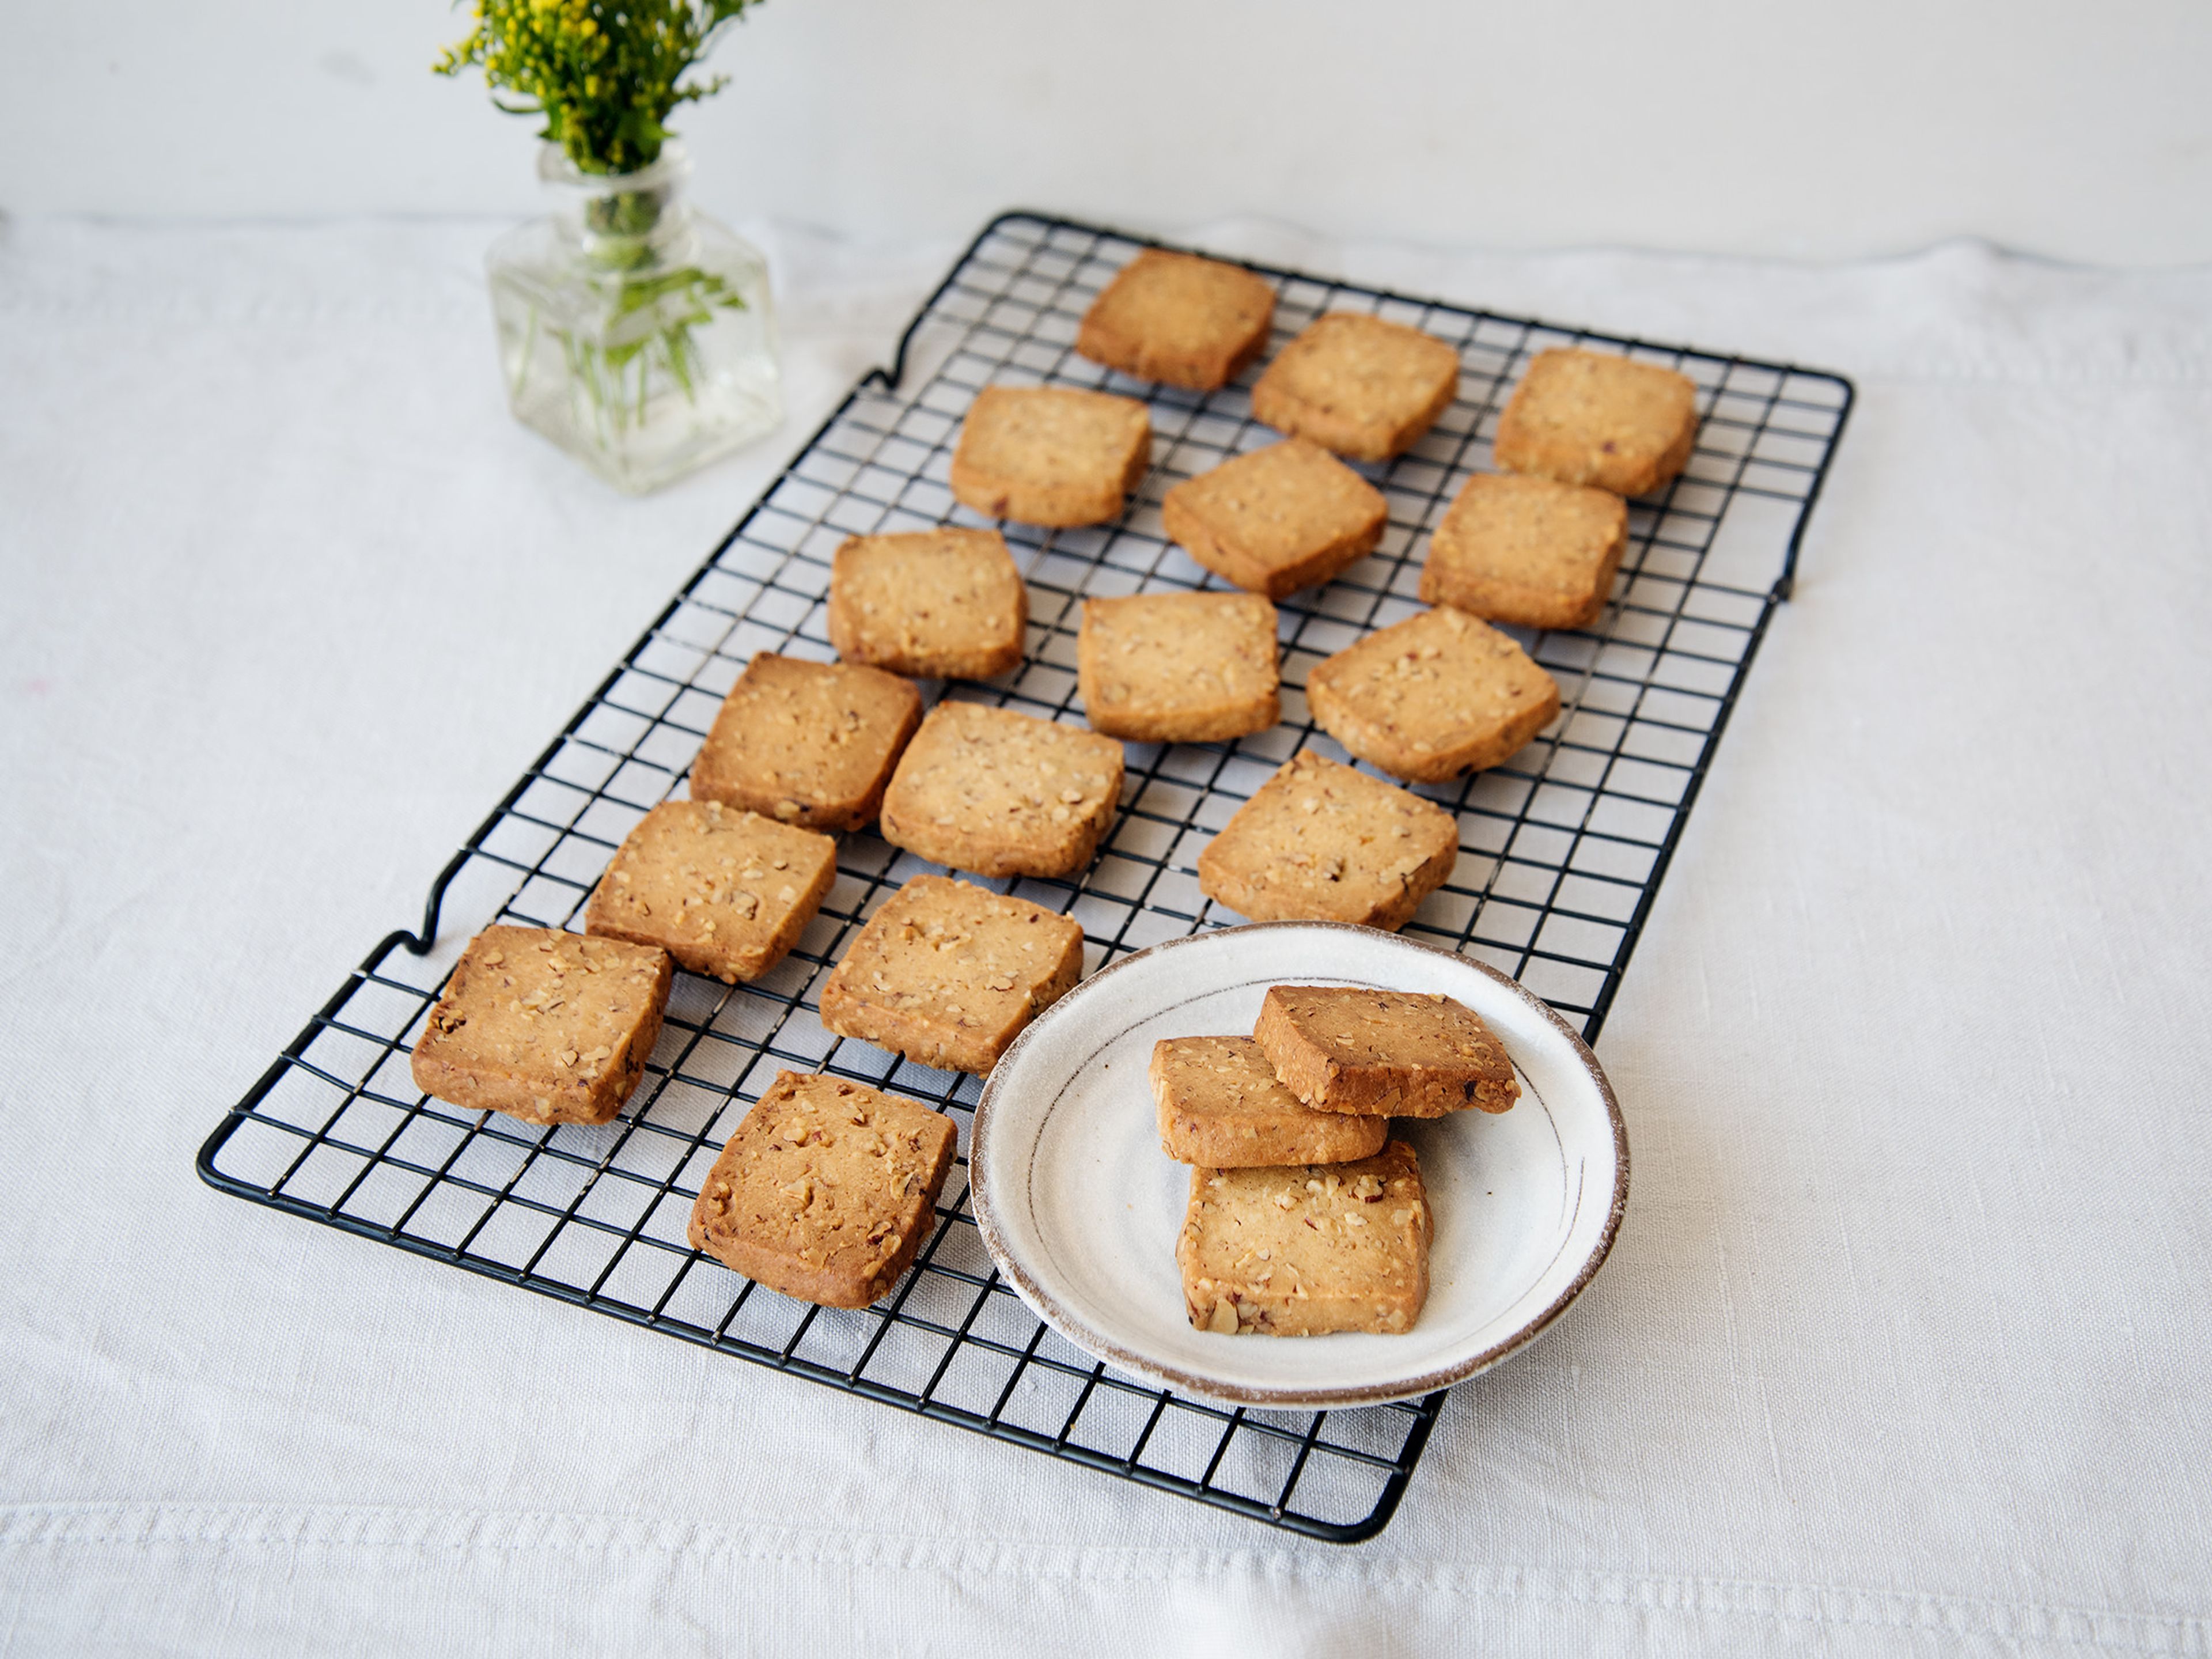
[484,142,783,493]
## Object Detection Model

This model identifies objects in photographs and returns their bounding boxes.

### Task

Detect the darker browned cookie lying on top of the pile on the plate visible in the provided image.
[1252,984,1520,1119]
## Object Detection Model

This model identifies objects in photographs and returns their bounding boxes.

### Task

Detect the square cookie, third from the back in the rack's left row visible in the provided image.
[830,529,1029,679]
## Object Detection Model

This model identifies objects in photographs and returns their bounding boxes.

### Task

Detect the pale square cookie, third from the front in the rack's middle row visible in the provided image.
[880,703,1122,876]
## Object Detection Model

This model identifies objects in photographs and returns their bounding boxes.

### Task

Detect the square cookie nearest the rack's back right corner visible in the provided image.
[1495,350,1696,495]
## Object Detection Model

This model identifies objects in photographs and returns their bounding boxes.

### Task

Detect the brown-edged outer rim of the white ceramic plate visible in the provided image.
[969,920,1628,1411]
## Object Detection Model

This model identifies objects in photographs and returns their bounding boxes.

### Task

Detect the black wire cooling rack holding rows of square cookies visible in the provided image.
[199,213,1851,1541]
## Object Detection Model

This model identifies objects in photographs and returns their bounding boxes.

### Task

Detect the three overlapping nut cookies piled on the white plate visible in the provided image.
[1150,984,1520,1336]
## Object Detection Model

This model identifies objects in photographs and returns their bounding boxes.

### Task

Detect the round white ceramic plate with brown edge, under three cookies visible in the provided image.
[969,922,1628,1409]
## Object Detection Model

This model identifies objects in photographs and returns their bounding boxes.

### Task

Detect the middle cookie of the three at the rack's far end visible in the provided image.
[1252,312,1460,460]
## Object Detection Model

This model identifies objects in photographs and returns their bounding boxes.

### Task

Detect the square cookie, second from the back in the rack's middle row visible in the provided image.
[1159,438,1389,600]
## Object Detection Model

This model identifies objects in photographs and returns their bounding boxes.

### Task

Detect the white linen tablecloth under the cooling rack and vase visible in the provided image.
[0,221,2212,1654]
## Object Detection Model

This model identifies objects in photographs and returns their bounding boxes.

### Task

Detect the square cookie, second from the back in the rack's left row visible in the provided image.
[951,385,1153,529]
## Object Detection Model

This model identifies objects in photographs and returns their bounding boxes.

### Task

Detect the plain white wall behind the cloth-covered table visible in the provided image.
[0,0,2212,263]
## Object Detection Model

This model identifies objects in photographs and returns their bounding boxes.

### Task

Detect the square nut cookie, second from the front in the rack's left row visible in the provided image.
[584,801,836,984]
